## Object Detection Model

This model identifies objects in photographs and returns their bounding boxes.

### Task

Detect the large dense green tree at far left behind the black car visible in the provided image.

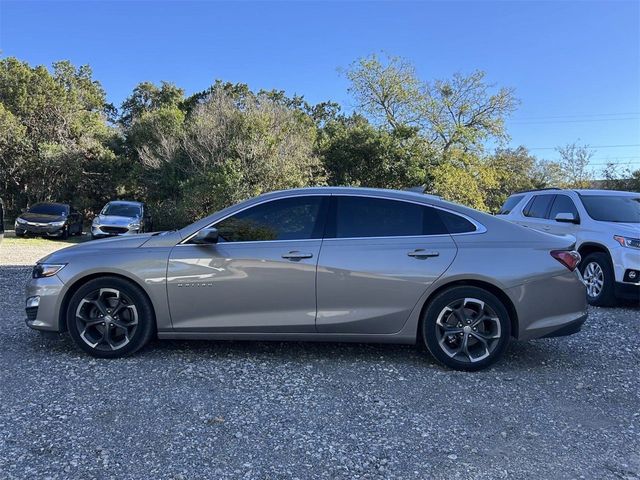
[0,58,117,217]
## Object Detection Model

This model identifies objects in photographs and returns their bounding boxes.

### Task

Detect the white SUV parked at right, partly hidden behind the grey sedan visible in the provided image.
[497,188,640,306]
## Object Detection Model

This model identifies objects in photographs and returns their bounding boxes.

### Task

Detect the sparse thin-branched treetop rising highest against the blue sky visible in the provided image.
[346,55,518,155]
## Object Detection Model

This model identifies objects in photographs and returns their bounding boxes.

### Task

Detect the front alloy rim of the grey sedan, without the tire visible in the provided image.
[75,288,138,351]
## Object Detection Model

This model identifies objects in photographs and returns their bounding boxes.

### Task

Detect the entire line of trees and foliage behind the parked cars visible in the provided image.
[0,55,640,228]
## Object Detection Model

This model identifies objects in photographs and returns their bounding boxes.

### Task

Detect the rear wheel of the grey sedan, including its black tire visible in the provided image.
[421,286,511,371]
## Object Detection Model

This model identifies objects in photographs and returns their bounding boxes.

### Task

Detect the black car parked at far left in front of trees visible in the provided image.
[15,203,83,239]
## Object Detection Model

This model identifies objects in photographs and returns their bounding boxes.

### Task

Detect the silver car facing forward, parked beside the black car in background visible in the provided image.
[91,200,153,239]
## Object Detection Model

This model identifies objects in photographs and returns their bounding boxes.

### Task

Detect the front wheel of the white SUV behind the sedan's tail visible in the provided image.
[580,252,616,307]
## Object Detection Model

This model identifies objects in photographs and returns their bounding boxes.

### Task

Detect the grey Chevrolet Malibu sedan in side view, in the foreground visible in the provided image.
[26,187,587,370]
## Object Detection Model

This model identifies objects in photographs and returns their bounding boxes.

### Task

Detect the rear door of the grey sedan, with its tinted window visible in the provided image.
[316,195,457,334]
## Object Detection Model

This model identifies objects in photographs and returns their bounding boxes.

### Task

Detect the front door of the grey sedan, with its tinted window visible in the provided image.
[167,195,329,333]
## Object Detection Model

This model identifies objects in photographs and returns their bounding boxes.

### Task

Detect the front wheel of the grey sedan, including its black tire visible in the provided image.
[67,277,156,358]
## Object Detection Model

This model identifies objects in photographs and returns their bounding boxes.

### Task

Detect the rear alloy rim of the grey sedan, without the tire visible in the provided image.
[436,298,502,363]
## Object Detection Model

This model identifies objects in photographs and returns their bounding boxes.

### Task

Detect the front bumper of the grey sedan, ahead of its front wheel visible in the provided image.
[25,275,64,332]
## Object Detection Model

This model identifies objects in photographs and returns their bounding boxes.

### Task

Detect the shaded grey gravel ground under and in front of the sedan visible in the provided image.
[0,267,640,479]
